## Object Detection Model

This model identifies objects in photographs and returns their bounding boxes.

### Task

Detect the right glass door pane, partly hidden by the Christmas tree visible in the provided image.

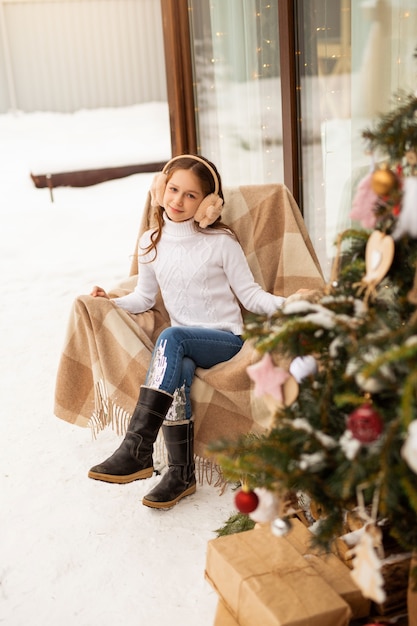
[296,0,417,277]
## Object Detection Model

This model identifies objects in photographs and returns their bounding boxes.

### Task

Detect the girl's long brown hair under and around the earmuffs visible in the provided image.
[141,155,237,259]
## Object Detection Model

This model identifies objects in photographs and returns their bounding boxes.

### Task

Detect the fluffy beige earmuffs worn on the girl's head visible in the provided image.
[150,154,223,228]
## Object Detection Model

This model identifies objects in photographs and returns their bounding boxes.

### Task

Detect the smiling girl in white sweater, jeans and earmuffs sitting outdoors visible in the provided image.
[88,155,285,508]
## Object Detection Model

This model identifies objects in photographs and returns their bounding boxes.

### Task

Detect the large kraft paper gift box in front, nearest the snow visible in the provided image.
[206,528,352,626]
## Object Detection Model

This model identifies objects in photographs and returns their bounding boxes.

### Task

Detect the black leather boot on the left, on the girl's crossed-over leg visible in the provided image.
[88,386,173,483]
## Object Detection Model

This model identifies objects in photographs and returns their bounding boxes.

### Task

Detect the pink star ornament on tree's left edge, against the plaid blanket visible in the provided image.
[246,352,298,406]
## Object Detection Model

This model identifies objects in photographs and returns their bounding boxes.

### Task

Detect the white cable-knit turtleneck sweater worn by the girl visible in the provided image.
[114,218,285,335]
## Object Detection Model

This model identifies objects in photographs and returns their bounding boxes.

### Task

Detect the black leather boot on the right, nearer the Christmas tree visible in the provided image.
[142,420,196,509]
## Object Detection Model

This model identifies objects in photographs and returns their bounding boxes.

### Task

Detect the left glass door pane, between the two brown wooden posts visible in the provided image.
[188,0,283,186]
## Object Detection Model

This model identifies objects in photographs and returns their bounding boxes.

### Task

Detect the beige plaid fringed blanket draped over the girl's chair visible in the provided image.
[55,185,324,457]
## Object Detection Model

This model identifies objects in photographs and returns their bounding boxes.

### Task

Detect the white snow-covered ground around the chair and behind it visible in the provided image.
[0,103,234,626]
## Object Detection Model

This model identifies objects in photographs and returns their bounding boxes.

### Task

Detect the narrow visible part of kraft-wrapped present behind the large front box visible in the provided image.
[285,518,371,618]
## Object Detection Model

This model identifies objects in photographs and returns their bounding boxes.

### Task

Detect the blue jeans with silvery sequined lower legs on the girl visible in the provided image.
[145,326,243,420]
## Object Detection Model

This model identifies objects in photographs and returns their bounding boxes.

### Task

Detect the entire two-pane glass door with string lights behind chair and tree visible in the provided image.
[184,0,417,278]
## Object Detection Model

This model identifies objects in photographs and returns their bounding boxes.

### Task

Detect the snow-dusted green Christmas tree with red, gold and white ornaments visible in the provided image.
[211,94,417,601]
